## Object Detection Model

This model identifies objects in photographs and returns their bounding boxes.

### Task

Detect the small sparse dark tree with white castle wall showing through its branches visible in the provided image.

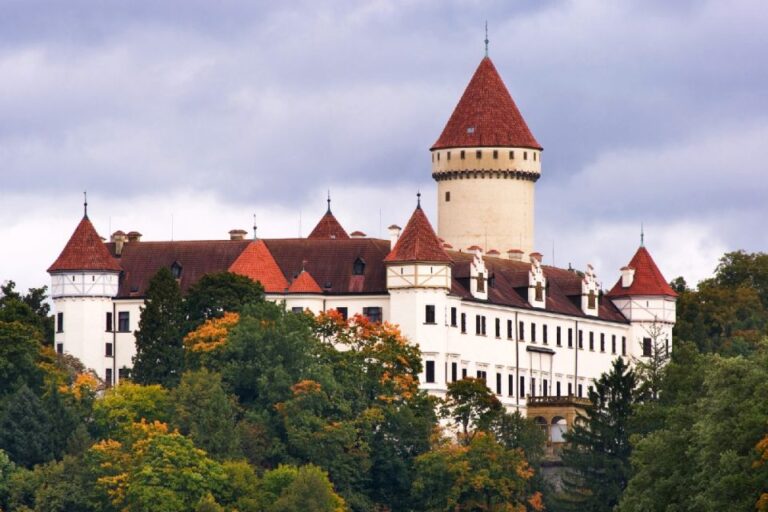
[441,377,503,444]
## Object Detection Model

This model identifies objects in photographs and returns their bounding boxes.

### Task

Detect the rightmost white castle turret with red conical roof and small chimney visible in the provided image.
[606,245,677,357]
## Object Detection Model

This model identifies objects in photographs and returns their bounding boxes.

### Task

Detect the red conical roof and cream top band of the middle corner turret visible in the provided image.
[384,194,451,290]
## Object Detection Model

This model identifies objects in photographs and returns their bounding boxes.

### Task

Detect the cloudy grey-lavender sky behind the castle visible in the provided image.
[0,0,768,289]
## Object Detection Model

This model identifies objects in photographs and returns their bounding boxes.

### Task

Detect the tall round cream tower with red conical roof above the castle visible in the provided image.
[430,56,542,254]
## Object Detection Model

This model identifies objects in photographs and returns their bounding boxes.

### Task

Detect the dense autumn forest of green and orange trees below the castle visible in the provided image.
[0,252,768,512]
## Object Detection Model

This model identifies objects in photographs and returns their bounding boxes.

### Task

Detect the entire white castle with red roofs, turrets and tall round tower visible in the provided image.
[48,56,676,442]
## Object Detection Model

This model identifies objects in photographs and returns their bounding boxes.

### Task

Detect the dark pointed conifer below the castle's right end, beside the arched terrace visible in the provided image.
[561,357,637,512]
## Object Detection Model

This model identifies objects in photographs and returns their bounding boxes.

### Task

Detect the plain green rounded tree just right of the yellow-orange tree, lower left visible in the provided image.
[171,369,241,459]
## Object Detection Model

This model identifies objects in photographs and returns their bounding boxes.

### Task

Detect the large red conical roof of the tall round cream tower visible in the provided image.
[432,56,542,149]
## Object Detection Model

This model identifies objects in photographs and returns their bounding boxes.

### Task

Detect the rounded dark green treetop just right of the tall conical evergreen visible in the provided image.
[185,272,264,330]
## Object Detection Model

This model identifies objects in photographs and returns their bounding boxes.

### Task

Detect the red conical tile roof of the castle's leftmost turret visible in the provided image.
[48,216,122,272]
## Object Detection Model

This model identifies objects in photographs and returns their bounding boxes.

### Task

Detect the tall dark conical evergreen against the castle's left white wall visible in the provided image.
[132,267,184,387]
